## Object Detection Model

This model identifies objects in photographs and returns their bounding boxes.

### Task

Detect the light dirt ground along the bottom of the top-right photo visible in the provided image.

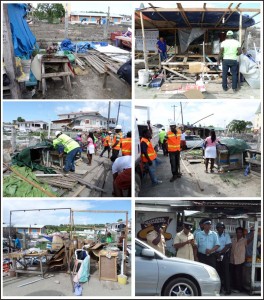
[135,82,260,100]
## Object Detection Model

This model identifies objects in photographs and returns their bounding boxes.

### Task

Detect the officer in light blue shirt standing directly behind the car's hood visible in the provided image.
[195,219,220,268]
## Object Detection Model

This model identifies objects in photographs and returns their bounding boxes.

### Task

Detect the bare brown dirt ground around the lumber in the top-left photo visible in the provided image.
[24,22,131,99]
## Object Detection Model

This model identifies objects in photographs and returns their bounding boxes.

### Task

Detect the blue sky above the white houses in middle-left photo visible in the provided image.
[2,100,131,132]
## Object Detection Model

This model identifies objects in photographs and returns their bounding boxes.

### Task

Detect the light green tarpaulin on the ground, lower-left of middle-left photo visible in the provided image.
[3,166,57,197]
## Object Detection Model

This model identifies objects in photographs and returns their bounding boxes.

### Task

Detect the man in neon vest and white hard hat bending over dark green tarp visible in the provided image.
[53,131,82,173]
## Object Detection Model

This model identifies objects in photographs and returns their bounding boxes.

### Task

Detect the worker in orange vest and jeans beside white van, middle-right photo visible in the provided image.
[140,129,162,186]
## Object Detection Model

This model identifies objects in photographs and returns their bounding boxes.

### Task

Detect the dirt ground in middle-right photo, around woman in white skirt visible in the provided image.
[139,151,261,198]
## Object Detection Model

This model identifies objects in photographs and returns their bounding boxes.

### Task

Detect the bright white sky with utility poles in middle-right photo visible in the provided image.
[135,99,260,127]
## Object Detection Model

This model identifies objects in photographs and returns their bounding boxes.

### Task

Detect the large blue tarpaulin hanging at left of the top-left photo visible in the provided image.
[7,3,38,59]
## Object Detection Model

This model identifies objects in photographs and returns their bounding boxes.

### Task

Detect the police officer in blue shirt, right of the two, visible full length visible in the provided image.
[215,222,232,295]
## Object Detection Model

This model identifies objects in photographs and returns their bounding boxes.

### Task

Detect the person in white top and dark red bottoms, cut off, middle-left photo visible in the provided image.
[112,155,132,197]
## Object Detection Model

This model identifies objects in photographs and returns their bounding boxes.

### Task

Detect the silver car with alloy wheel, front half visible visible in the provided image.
[135,239,221,297]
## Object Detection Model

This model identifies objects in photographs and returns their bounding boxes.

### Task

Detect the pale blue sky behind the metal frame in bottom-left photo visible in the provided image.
[2,199,131,225]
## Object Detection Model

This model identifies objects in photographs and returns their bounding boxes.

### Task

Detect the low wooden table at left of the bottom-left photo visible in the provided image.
[8,251,48,277]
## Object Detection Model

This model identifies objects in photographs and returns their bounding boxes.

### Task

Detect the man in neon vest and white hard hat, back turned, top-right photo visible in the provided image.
[218,30,241,92]
